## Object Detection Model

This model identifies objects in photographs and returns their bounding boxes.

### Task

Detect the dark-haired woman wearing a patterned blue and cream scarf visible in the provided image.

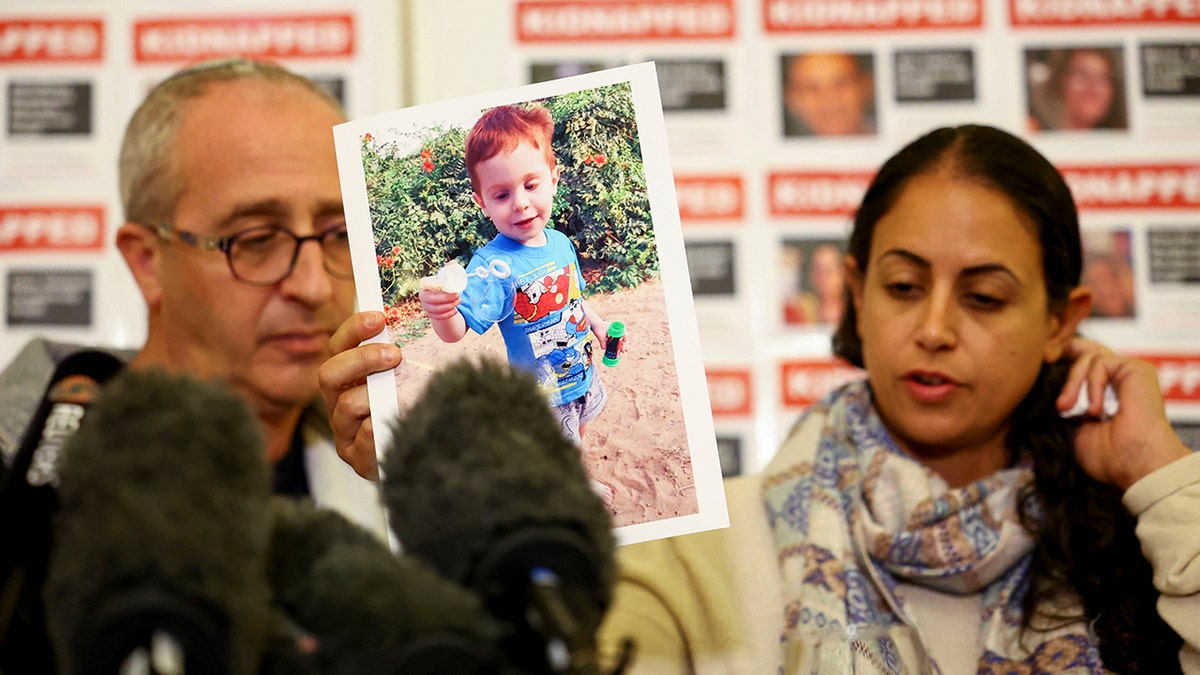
[601,126,1200,674]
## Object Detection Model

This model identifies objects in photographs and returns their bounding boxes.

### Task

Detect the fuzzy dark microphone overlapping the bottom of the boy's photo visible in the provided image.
[380,358,616,674]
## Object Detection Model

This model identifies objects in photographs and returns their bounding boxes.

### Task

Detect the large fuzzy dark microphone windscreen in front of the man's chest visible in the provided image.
[46,370,270,675]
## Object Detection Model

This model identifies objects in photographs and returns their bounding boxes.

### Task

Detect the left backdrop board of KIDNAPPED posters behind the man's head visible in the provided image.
[0,0,403,364]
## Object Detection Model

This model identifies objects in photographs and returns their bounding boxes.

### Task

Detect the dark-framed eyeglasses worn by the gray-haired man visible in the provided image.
[155,223,354,286]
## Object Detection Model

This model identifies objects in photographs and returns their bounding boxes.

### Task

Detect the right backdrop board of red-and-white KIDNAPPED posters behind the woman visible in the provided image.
[410,0,1200,471]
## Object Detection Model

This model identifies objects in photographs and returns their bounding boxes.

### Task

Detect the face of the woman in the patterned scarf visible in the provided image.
[851,172,1074,484]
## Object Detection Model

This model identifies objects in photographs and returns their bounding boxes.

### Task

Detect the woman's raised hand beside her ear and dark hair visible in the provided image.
[1056,338,1192,490]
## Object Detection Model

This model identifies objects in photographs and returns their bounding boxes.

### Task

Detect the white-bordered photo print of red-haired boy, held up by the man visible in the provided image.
[334,62,728,544]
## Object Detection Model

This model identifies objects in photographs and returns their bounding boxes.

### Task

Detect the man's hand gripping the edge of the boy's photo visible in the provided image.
[317,311,403,480]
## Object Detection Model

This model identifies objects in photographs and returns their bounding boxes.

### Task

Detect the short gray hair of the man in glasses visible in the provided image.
[119,58,346,226]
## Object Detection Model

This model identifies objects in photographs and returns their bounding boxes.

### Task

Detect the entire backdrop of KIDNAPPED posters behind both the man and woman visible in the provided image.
[0,0,1200,471]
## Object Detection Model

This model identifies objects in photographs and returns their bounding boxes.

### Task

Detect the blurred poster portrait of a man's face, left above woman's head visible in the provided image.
[782,52,875,136]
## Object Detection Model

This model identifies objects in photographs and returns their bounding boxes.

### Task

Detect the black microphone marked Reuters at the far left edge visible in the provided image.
[0,351,121,673]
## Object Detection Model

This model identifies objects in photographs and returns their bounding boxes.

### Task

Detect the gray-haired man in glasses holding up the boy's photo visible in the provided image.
[0,59,386,669]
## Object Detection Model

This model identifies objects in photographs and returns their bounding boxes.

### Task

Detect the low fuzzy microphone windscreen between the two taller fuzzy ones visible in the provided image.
[268,497,500,675]
